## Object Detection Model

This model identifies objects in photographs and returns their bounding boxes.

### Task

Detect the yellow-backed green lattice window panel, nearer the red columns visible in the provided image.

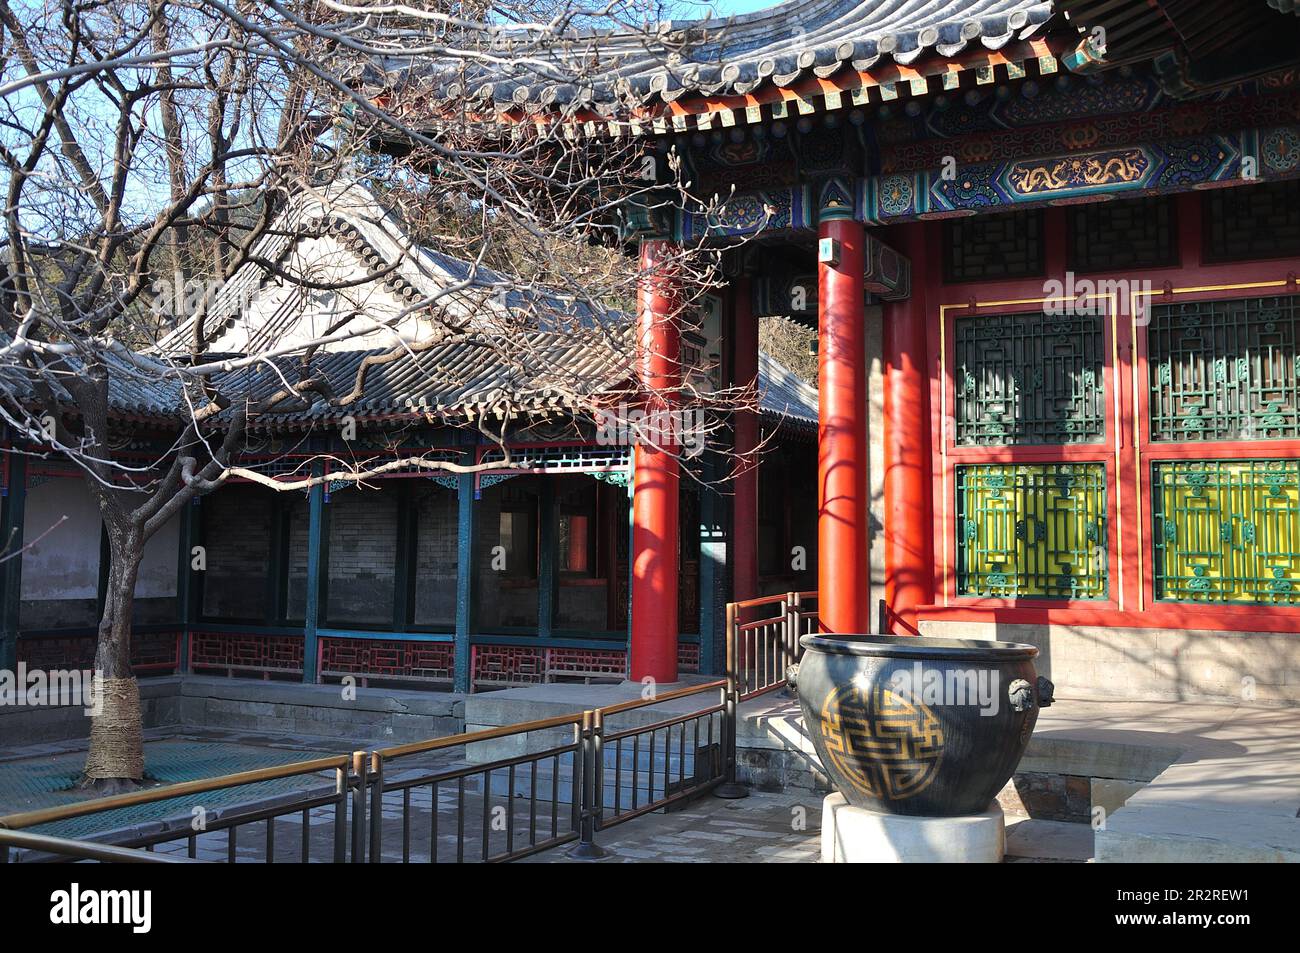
[956,463,1106,599]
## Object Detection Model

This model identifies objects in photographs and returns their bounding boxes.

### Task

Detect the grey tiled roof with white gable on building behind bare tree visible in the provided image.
[22,176,818,430]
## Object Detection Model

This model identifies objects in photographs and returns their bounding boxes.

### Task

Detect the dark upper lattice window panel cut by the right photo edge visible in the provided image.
[1147,296,1300,442]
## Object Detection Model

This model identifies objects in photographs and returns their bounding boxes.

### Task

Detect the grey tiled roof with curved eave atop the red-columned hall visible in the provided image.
[369,0,1055,105]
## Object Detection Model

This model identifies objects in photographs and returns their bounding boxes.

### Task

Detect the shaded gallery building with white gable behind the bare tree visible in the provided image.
[0,185,816,690]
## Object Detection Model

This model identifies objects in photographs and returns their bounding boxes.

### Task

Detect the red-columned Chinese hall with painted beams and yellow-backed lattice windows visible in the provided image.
[361,0,1300,701]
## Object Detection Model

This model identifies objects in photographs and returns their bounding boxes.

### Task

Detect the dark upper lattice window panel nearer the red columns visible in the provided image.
[954,312,1106,446]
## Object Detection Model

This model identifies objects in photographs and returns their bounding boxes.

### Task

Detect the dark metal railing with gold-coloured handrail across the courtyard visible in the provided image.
[0,593,818,863]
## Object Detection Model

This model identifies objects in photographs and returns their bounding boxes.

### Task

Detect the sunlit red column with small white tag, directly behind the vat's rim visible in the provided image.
[818,217,871,632]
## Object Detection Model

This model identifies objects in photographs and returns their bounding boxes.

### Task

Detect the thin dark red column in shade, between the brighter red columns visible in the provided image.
[729,278,758,602]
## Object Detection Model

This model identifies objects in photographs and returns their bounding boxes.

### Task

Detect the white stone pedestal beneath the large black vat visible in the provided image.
[822,792,1006,863]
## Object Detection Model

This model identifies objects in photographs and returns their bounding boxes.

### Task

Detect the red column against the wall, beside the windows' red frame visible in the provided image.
[884,222,935,634]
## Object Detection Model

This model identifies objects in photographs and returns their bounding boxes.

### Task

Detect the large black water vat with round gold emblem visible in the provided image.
[796,634,1052,816]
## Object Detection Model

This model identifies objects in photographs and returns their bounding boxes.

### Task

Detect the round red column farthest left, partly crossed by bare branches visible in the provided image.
[628,239,681,683]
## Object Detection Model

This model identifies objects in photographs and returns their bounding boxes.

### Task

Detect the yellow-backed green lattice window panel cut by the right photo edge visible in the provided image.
[1152,460,1300,605]
